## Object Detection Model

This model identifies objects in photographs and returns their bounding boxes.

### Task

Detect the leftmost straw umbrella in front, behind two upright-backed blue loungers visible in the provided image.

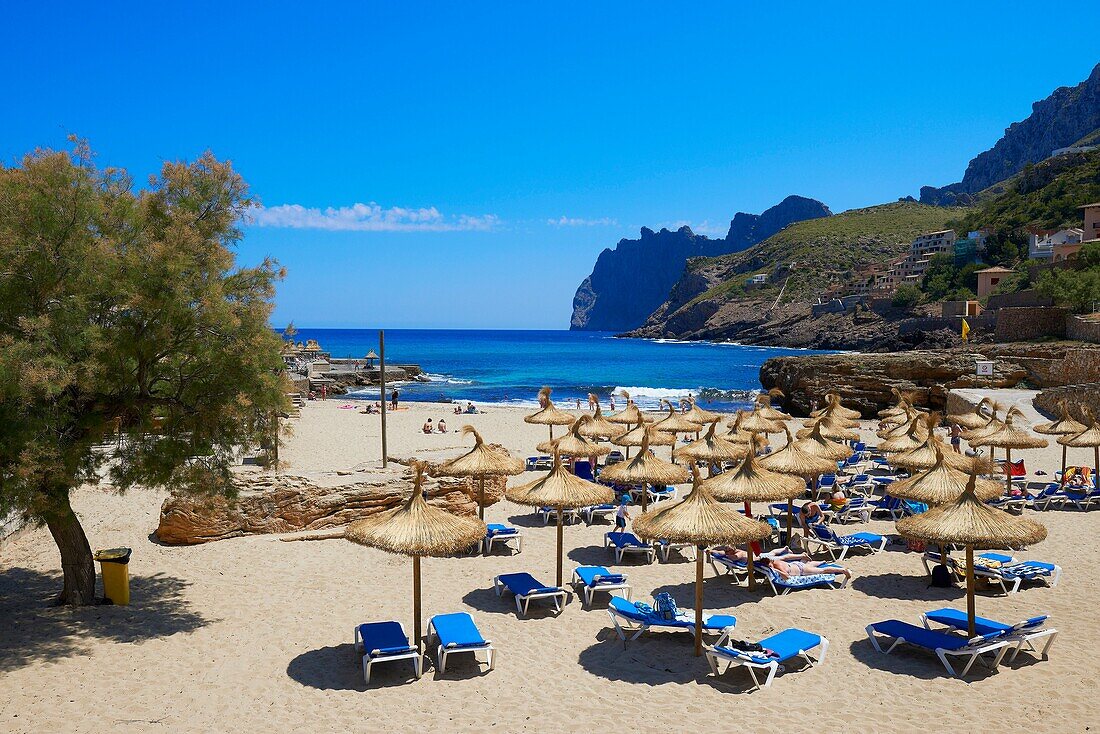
[344,461,486,650]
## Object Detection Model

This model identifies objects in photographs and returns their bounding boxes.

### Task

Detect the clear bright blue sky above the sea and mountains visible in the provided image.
[0,2,1100,329]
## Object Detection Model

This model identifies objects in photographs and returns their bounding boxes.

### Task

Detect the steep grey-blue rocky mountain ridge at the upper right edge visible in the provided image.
[921,64,1100,206]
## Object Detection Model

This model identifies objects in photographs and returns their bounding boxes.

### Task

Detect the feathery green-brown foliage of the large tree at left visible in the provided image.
[0,143,285,603]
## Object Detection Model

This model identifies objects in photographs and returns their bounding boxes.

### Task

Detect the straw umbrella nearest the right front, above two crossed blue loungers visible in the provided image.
[897,475,1046,637]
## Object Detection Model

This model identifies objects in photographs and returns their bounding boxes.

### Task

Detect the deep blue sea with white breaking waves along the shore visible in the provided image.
[295,328,827,410]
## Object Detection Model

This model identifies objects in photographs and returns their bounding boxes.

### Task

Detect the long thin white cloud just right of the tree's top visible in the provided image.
[250,201,501,232]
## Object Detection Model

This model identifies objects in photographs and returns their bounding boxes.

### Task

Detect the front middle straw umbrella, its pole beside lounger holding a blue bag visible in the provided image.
[634,467,771,657]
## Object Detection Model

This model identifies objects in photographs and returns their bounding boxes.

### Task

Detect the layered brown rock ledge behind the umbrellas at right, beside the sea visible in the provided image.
[760,342,1100,417]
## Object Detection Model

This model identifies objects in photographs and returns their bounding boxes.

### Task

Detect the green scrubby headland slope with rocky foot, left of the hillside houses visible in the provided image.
[628,201,963,347]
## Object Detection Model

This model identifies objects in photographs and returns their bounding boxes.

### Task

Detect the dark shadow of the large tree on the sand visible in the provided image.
[0,568,210,671]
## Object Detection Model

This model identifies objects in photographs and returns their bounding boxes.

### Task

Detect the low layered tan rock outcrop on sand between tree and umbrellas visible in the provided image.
[156,474,505,546]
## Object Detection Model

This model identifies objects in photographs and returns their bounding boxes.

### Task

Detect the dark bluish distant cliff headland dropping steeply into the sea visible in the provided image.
[570,196,832,331]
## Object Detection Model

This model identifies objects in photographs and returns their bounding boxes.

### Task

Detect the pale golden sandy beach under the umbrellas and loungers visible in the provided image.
[0,399,1100,733]
